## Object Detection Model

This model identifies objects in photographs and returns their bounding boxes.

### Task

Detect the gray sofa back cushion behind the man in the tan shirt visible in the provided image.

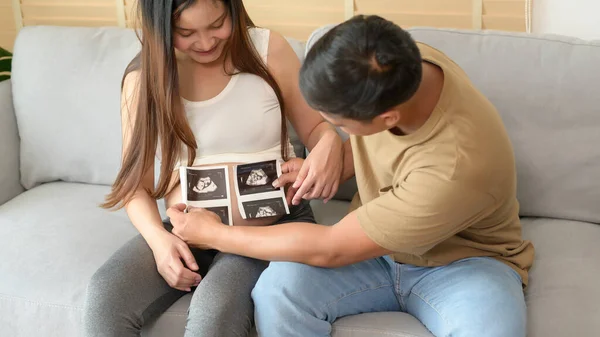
[307,26,600,223]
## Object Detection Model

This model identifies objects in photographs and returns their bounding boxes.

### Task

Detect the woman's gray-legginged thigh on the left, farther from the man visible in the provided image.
[84,231,185,337]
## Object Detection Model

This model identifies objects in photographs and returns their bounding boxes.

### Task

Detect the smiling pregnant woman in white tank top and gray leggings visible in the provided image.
[84,0,342,337]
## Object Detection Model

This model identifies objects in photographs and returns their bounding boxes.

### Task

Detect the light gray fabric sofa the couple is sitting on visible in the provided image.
[0,27,600,337]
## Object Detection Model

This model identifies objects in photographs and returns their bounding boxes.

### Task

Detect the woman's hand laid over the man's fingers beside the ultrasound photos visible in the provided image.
[274,130,343,205]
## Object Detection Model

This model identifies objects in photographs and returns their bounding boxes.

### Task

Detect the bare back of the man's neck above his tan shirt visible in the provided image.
[391,61,444,135]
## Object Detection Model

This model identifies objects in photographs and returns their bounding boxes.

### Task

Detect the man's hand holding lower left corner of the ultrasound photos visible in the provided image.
[167,204,224,249]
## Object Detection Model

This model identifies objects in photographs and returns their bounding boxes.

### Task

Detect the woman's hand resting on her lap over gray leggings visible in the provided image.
[151,232,202,291]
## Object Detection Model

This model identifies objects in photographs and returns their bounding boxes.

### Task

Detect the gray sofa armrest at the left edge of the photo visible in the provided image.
[0,80,24,205]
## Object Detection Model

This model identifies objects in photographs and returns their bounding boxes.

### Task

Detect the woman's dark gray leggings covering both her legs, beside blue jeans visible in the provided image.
[84,203,315,337]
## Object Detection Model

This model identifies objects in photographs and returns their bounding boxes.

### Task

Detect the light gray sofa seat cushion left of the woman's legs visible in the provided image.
[0,183,136,336]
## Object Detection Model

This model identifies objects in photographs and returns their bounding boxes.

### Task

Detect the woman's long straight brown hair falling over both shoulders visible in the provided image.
[101,0,288,209]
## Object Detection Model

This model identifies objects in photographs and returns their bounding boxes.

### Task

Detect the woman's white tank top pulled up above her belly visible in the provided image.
[173,28,294,166]
